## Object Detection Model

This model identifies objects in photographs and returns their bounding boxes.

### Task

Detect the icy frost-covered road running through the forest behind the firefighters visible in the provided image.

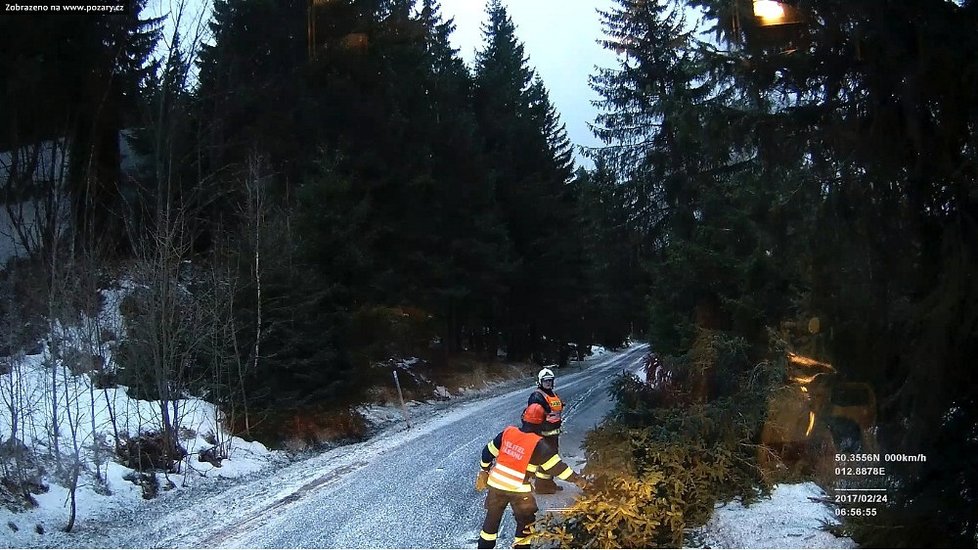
[42,345,647,548]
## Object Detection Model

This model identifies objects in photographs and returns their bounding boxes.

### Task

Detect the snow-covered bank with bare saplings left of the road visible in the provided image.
[0,351,281,547]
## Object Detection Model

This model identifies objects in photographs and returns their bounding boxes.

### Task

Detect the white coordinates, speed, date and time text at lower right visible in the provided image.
[830,453,927,518]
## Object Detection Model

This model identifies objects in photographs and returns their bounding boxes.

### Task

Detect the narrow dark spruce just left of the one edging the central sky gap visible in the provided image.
[412,0,509,357]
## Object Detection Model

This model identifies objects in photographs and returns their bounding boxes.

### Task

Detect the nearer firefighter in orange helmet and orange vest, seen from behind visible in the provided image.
[475,404,586,548]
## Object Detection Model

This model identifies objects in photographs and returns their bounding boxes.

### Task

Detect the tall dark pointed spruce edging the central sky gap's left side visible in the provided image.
[473,0,580,360]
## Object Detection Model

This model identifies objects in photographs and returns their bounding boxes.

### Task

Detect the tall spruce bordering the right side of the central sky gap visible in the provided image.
[592,0,722,350]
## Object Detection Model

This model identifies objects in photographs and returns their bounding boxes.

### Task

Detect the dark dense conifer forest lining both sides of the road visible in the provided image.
[0,0,978,547]
